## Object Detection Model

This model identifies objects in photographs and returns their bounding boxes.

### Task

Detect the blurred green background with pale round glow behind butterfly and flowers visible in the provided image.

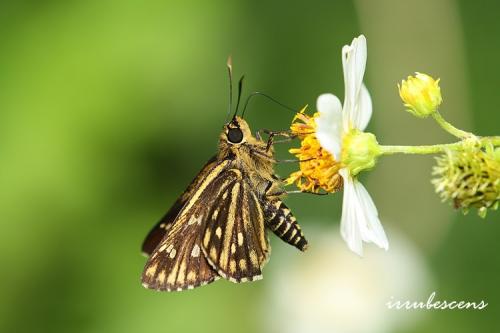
[0,0,500,333]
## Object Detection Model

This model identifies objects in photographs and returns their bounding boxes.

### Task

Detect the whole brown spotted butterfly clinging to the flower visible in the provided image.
[142,59,308,291]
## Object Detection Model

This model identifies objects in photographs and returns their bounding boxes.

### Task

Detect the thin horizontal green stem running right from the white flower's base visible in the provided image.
[380,136,500,155]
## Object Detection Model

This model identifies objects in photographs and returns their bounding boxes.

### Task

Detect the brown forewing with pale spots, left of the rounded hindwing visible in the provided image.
[142,160,236,291]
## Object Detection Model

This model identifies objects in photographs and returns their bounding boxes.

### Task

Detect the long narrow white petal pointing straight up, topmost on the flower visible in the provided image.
[342,35,367,130]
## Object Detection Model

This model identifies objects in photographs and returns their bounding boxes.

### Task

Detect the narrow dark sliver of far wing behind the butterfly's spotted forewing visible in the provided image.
[142,156,216,256]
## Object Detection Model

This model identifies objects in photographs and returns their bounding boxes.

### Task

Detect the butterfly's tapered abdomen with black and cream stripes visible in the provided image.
[264,200,308,251]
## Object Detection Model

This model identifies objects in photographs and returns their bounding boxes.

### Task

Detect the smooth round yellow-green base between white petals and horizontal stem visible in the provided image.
[341,129,381,176]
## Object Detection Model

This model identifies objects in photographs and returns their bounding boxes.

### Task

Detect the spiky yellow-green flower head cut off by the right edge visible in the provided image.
[432,144,500,217]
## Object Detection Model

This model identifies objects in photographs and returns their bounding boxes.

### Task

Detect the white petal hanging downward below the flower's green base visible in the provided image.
[340,169,389,255]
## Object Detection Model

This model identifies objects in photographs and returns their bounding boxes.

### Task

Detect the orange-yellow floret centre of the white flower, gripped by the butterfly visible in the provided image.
[286,108,342,193]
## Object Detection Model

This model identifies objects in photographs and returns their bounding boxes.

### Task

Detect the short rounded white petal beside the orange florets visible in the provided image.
[316,94,342,160]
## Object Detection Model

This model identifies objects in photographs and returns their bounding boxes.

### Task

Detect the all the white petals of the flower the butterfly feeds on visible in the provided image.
[316,35,389,256]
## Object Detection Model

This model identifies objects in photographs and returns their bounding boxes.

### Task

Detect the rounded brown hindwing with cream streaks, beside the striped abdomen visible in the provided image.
[202,169,270,282]
